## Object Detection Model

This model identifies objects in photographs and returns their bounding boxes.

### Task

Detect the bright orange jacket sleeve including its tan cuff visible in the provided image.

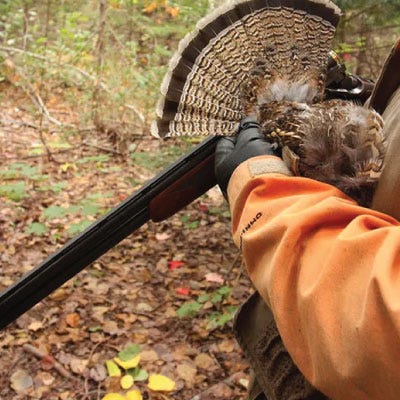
[228,156,400,400]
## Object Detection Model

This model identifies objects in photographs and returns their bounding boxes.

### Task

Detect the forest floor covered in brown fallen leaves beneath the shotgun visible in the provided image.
[0,85,251,400]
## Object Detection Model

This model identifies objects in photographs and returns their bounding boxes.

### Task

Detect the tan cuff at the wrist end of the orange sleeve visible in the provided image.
[228,156,293,200]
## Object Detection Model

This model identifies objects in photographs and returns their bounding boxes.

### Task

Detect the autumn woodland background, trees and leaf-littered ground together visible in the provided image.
[0,0,400,400]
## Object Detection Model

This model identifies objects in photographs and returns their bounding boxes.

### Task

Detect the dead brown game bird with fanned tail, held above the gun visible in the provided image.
[152,0,385,206]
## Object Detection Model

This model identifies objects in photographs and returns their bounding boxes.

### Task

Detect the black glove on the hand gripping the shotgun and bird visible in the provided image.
[214,117,275,198]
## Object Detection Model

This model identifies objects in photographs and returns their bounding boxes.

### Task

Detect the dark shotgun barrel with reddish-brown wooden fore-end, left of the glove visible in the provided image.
[0,136,219,329]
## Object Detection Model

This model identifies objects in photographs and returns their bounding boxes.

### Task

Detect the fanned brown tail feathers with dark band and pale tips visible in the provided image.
[152,0,341,137]
